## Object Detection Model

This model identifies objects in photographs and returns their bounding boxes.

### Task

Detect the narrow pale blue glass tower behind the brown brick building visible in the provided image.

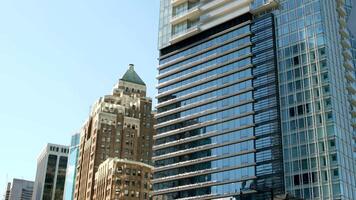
[63,133,80,200]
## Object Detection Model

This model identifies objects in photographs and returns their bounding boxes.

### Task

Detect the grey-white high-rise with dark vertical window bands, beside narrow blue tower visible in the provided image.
[32,144,69,200]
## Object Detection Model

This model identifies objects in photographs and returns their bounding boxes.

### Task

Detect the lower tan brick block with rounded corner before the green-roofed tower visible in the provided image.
[93,158,153,200]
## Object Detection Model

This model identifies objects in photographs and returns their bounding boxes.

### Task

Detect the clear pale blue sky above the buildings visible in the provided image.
[0,0,159,194]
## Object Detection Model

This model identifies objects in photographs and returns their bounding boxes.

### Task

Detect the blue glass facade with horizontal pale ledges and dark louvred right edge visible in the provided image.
[153,15,284,199]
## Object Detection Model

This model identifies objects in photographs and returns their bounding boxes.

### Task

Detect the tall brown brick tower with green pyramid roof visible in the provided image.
[74,65,154,200]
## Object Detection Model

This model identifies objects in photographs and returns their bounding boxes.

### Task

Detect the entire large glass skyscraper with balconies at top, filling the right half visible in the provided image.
[153,0,356,200]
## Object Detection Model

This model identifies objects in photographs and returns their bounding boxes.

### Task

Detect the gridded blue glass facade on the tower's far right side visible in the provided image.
[275,0,356,199]
